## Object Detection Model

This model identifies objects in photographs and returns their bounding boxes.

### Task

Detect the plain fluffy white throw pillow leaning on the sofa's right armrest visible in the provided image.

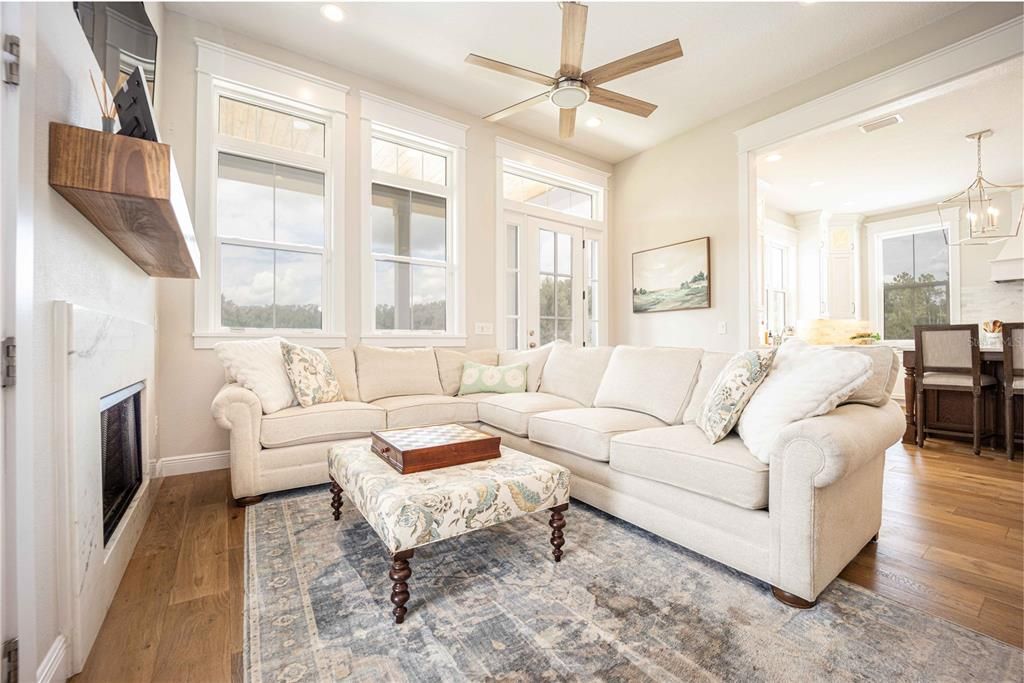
[736,339,871,464]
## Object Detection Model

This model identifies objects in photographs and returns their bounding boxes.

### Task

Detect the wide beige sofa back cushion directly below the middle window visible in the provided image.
[355,344,444,403]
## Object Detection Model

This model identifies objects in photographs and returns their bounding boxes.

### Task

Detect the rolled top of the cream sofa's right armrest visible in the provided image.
[770,400,906,488]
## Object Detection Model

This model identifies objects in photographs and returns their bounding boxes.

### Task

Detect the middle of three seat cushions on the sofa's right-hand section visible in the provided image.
[529,408,665,463]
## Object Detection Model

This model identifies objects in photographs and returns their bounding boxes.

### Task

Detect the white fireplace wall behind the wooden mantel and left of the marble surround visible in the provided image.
[19,3,156,680]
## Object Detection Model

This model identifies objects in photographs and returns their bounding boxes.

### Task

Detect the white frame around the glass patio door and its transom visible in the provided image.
[495,137,611,349]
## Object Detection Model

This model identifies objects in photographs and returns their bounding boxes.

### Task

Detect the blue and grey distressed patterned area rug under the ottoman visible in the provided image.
[245,486,1024,683]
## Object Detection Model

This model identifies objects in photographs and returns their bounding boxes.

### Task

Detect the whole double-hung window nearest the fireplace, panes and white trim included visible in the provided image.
[196,44,344,346]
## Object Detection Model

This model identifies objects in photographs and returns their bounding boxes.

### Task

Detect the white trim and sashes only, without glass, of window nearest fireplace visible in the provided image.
[193,39,348,348]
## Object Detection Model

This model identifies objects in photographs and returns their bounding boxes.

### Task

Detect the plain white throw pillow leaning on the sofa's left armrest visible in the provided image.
[213,337,296,414]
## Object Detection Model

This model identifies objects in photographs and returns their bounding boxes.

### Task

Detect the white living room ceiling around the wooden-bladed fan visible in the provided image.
[169,2,966,163]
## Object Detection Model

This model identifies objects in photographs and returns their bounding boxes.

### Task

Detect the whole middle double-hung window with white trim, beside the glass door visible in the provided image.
[362,94,465,345]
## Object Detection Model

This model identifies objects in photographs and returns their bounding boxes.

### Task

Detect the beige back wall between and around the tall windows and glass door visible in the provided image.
[157,11,611,471]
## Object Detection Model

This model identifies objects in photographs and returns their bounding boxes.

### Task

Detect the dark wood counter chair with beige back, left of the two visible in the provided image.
[913,325,998,456]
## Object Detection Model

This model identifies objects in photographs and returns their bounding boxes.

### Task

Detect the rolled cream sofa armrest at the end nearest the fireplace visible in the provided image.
[210,384,263,499]
